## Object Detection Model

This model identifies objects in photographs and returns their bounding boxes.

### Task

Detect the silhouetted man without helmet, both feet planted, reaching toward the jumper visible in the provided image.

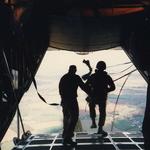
[59,65,87,146]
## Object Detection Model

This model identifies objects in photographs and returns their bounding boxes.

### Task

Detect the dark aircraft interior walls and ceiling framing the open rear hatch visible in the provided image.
[0,0,150,150]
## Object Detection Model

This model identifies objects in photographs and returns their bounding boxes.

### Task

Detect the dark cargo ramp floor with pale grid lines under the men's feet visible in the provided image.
[13,132,144,150]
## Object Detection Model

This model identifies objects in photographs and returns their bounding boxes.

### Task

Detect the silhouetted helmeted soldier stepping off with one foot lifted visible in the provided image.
[87,61,115,136]
